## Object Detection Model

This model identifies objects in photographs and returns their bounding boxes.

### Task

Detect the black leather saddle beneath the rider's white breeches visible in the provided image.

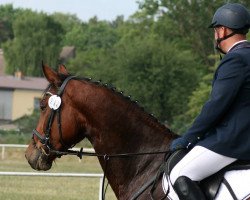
[163,149,250,200]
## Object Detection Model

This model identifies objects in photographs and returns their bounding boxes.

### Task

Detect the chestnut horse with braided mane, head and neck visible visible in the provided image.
[25,66,176,200]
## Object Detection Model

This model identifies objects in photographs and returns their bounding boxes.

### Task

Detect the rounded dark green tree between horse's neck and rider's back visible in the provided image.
[110,35,202,121]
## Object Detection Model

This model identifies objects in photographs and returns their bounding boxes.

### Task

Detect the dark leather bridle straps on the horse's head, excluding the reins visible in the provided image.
[32,76,75,157]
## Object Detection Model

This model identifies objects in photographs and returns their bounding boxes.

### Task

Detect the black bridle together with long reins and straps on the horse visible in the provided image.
[32,76,170,200]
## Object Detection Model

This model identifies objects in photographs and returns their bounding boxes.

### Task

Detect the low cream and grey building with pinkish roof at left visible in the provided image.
[0,72,48,121]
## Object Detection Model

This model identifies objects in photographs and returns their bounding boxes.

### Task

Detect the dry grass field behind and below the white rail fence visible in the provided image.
[0,148,116,200]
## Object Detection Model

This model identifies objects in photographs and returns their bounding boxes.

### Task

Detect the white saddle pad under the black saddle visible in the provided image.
[162,170,250,200]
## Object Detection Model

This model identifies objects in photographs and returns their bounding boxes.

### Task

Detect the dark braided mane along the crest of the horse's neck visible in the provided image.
[59,74,173,134]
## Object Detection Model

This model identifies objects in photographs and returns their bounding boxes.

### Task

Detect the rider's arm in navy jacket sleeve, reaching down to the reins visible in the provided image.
[183,53,247,143]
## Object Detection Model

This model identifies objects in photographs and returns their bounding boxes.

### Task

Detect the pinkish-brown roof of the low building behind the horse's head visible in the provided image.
[0,76,48,90]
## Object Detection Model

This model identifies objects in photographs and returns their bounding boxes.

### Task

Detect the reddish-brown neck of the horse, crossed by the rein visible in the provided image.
[74,81,171,196]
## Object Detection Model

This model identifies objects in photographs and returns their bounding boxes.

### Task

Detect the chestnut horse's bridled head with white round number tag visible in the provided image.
[25,65,85,170]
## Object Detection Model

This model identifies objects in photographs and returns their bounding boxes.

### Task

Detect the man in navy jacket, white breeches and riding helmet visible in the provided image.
[170,3,250,200]
